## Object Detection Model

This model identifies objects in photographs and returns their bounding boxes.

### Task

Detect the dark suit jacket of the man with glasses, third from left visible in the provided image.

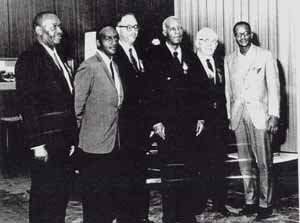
[114,46,150,149]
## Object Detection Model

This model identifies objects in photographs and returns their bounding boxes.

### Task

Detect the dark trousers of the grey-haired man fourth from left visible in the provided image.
[159,136,200,223]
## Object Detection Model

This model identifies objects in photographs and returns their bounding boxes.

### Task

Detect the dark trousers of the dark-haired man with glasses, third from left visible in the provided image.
[116,149,150,223]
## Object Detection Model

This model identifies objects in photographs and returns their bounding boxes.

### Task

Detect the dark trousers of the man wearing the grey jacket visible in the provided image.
[79,151,119,223]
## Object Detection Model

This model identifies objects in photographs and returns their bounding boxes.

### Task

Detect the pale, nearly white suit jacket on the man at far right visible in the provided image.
[225,44,280,129]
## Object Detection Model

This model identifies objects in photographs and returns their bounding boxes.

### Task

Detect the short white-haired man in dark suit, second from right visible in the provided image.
[195,27,231,216]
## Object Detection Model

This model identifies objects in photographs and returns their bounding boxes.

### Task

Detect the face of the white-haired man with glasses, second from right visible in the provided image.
[195,35,218,56]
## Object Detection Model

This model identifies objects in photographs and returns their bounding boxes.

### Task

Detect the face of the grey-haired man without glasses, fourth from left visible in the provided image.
[163,20,183,45]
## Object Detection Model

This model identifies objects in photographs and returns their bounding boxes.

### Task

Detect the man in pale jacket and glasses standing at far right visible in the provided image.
[225,21,280,220]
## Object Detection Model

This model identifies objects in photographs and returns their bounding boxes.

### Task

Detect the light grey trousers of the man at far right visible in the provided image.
[235,109,273,208]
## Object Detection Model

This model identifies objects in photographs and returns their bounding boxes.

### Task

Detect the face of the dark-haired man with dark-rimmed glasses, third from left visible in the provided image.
[117,15,139,45]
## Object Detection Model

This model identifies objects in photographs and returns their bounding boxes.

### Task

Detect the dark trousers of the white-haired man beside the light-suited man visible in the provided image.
[197,119,227,209]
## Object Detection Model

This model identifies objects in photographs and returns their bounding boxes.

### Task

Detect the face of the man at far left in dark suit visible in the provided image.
[38,14,63,48]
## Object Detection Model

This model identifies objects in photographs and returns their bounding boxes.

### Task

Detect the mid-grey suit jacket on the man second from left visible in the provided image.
[74,53,123,154]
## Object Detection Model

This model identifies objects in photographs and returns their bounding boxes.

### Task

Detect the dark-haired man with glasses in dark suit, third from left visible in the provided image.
[115,13,150,223]
